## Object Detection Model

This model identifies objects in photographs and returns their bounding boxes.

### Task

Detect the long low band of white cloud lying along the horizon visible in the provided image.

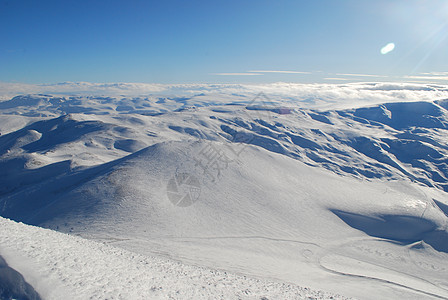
[0,78,448,109]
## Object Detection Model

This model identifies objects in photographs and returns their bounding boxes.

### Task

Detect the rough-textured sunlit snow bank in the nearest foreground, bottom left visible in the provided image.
[0,218,344,299]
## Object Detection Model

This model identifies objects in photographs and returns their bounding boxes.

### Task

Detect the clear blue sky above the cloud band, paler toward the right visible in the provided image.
[0,0,448,84]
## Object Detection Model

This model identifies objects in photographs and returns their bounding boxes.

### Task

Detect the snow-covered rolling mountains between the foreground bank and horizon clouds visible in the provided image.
[0,84,448,299]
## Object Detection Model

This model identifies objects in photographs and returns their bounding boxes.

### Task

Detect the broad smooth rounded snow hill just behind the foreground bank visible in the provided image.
[4,142,447,298]
